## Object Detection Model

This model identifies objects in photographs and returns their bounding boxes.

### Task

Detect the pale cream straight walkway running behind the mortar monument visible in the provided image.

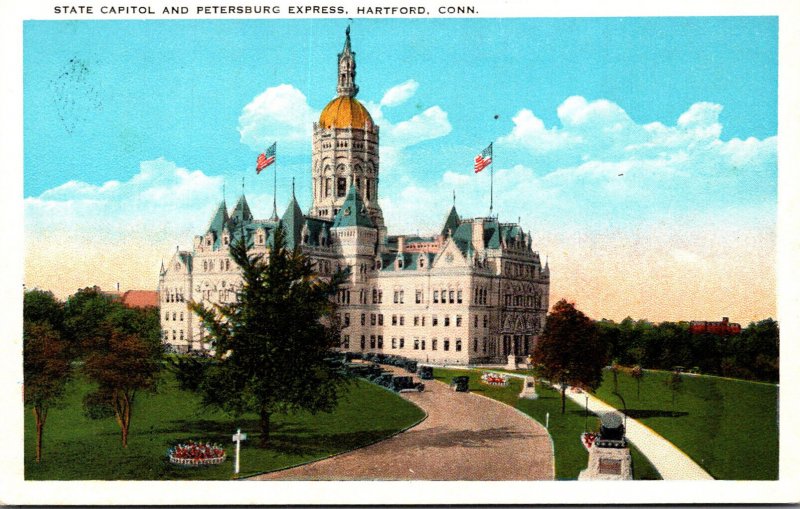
[567,390,714,481]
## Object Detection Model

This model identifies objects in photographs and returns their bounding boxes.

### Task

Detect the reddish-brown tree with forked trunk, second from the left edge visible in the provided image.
[83,322,162,447]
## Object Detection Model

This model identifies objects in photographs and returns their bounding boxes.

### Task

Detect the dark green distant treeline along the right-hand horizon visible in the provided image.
[595,317,779,382]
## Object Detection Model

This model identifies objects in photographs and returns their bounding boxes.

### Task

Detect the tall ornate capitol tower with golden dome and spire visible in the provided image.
[310,26,386,244]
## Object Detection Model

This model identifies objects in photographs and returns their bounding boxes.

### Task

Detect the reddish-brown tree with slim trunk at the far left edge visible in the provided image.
[22,321,70,463]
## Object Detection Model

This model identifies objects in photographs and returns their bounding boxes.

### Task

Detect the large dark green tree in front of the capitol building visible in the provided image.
[189,225,344,447]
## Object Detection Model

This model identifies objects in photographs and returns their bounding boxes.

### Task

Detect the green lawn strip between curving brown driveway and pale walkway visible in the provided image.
[434,368,661,479]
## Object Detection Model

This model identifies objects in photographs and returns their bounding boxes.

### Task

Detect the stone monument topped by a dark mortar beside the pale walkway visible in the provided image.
[578,412,633,481]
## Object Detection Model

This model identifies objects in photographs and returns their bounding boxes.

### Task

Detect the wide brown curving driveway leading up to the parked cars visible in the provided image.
[250,370,554,481]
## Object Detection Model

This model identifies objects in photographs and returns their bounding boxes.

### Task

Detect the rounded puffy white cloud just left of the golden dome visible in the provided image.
[239,84,319,151]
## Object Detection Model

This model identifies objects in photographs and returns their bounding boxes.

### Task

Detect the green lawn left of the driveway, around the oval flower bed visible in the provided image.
[25,373,424,480]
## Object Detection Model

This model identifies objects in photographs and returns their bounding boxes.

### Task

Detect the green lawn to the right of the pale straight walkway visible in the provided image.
[597,371,778,480]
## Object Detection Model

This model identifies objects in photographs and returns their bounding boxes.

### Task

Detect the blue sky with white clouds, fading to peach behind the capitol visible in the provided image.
[23,17,778,319]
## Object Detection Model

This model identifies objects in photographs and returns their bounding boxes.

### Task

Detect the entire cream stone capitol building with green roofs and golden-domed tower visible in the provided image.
[158,29,550,364]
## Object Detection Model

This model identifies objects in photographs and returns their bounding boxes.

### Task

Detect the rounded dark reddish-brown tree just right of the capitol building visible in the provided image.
[533,299,608,414]
